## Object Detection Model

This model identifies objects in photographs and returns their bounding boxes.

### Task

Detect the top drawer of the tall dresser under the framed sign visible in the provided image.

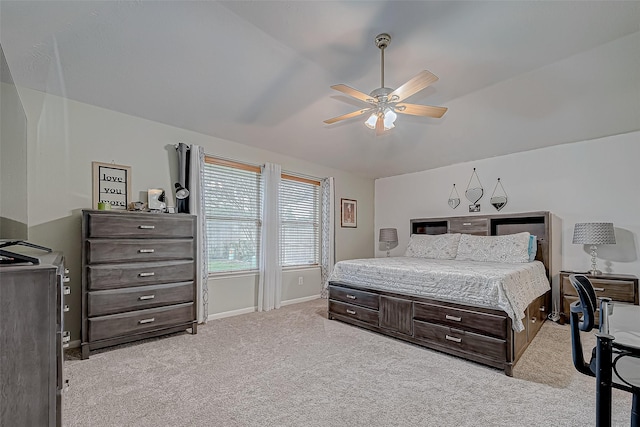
[87,212,195,239]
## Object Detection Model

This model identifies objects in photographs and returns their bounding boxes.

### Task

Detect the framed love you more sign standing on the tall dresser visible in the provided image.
[91,162,131,210]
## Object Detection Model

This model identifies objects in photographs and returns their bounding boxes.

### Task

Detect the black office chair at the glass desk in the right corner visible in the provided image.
[569,274,640,427]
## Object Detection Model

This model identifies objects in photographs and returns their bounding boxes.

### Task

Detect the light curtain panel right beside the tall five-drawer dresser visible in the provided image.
[187,145,209,323]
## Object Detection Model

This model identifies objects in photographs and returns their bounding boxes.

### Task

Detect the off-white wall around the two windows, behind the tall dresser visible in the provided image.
[19,88,374,340]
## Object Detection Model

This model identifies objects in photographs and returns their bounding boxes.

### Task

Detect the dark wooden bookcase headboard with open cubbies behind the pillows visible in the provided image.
[410,211,560,280]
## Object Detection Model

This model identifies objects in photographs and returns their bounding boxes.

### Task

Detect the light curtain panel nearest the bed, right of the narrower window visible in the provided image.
[320,177,335,298]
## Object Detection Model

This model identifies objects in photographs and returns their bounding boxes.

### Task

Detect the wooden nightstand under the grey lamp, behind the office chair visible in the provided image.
[560,271,638,323]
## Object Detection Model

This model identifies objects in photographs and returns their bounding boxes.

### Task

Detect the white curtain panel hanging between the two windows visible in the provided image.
[258,163,282,311]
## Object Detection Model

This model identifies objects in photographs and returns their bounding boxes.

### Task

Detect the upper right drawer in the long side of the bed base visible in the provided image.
[413,302,507,339]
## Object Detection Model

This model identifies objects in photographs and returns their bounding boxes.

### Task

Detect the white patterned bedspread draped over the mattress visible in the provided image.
[329,257,551,332]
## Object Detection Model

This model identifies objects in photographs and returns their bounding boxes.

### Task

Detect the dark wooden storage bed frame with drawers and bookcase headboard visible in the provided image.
[328,212,560,376]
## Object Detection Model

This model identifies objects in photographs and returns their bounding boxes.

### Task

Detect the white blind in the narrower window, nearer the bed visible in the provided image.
[280,174,320,267]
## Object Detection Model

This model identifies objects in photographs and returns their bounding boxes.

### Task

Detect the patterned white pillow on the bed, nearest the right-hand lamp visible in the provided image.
[456,232,530,263]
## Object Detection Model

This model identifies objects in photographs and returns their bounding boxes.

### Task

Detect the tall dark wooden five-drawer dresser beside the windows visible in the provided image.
[82,210,197,359]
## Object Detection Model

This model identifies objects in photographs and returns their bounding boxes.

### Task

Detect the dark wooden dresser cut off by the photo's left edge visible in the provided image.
[0,252,69,427]
